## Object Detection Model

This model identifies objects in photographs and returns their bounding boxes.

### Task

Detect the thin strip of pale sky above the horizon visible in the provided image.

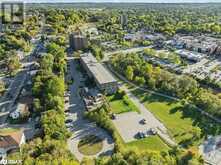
[0,0,221,3]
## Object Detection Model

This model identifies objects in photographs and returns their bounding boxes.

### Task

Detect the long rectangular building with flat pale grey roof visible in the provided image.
[80,53,118,94]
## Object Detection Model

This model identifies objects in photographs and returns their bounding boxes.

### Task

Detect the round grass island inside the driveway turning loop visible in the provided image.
[78,135,103,155]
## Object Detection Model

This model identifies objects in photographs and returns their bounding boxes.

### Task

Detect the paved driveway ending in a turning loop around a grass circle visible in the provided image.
[67,58,114,161]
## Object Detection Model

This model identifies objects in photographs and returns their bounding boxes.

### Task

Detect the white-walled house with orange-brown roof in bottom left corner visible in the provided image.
[0,130,25,160]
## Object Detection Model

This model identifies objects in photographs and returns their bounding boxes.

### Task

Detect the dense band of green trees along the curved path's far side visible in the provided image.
[111,54,221,117]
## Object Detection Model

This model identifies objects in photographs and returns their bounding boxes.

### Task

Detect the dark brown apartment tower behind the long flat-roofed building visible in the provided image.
[69,32,88,50]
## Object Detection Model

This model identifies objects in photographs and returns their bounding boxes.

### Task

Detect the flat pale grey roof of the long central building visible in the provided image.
[80,53,117,84]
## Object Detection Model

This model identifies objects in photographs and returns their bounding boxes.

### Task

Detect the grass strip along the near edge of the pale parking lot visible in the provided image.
[125,136,170,152]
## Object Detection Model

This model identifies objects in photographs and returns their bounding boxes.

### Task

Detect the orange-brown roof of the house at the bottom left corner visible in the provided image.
[0,131,23,148]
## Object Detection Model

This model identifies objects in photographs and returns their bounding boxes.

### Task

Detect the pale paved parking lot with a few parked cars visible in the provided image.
[113,112,154,143]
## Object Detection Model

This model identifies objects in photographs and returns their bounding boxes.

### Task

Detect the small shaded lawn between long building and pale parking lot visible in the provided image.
[107,92,139,114]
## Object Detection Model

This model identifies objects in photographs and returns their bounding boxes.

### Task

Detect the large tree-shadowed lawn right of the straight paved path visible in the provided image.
[133,89,221,148]
